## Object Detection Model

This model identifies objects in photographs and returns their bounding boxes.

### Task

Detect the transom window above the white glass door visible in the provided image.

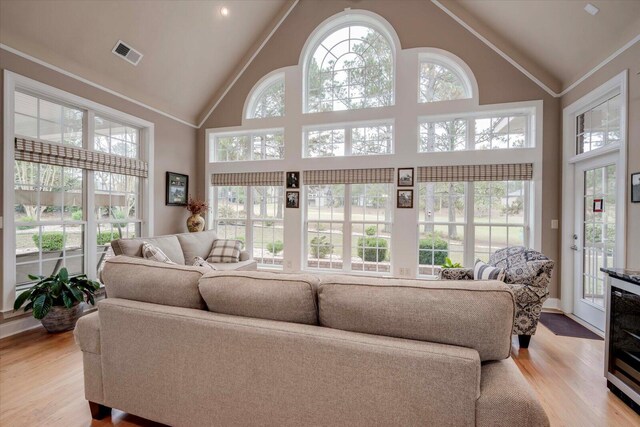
[576,94,621,154]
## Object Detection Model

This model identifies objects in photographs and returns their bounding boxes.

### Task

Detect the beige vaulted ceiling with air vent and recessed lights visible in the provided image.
[0,0,640,124]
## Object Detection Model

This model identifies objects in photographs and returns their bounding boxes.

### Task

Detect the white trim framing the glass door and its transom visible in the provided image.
[560,70,629,313]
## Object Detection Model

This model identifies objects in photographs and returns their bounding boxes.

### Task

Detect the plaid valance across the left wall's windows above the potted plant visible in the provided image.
[15,137,149,178]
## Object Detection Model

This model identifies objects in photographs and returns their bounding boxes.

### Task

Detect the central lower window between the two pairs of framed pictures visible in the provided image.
[305,184,393,273]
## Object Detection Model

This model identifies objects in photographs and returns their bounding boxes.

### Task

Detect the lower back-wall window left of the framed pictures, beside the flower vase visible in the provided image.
[212,186,284,266]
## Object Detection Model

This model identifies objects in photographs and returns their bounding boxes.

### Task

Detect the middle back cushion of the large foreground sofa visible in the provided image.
[200,271,319,325]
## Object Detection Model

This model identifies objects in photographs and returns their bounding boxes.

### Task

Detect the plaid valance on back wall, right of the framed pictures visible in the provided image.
[418,163,533,182]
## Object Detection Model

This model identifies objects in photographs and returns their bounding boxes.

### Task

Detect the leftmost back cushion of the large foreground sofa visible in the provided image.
[102,255,211,310]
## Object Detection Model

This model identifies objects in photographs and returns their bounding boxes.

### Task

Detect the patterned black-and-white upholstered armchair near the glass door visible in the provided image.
[440,246,555,348]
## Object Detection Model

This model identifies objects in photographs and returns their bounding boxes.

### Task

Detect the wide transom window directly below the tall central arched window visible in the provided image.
[304,122,393,157]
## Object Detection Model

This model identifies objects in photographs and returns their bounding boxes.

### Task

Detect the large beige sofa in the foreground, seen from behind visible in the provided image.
[75,256,549,427]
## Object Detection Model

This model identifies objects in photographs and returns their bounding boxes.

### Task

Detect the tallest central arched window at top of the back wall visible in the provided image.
[306,21,394,113]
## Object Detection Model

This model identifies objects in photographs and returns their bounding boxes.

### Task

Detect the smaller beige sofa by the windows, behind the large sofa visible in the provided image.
[111,230,258,270]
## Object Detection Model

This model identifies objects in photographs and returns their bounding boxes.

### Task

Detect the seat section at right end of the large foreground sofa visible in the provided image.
[476,358,549,427]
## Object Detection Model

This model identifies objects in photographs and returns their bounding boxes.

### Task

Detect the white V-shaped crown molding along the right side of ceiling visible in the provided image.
[431,0,640,98]
